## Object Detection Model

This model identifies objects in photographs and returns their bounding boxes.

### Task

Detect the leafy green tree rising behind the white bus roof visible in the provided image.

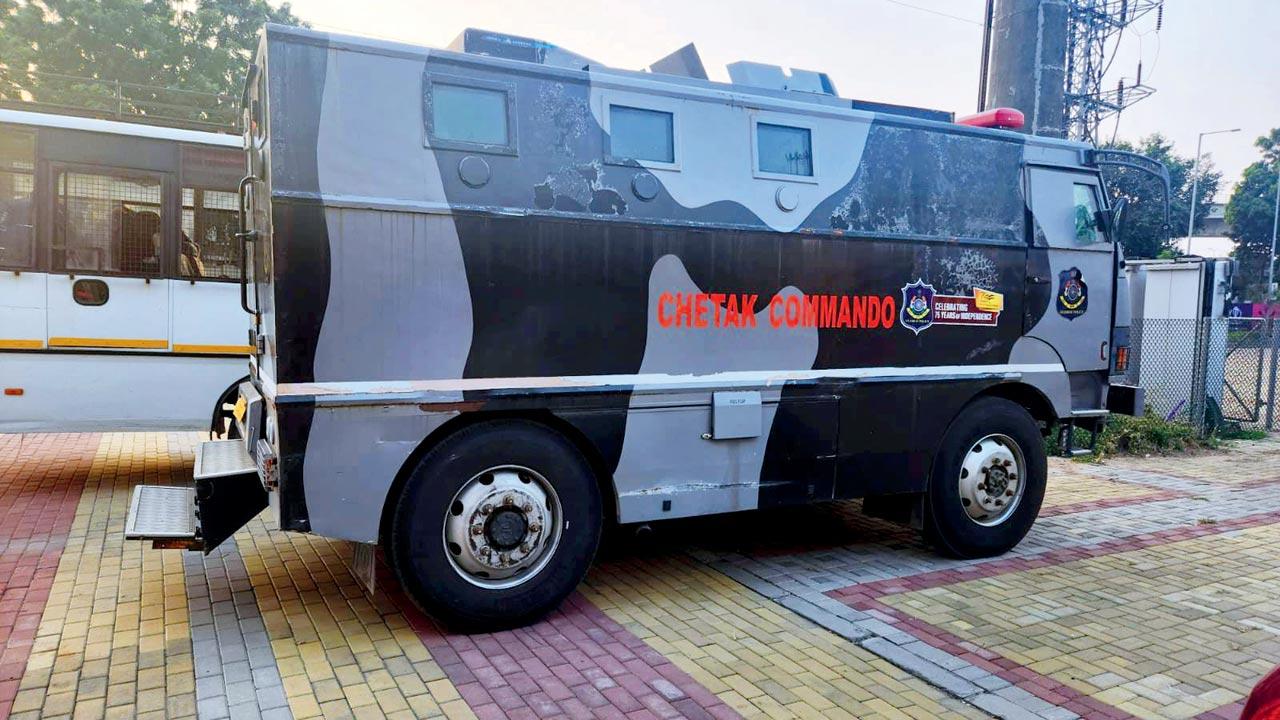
[0,0,300,124]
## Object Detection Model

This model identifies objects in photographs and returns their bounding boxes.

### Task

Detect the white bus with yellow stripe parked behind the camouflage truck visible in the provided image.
[0,109,251,432]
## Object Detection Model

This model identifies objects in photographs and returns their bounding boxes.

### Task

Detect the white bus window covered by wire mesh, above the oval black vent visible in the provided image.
[52,170,164,275]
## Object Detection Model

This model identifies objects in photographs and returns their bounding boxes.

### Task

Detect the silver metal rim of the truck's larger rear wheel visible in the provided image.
[444,465,563,589]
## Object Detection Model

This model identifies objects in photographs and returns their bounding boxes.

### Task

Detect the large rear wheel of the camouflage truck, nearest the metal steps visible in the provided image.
[389,420,603,630]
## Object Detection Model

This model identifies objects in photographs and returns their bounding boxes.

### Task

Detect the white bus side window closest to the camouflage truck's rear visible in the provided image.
[178,187,241,281]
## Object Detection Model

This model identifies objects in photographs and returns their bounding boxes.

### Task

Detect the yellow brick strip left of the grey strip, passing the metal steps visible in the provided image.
[12,433,196,720]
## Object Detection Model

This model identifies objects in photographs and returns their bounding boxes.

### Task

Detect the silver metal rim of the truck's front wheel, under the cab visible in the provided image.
[960,434,1027,527]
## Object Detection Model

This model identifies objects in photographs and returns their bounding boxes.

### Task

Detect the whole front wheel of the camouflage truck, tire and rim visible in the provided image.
[924,397,1048,557]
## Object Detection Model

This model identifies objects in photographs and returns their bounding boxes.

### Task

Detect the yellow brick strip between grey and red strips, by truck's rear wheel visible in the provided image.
[236,514,475,720]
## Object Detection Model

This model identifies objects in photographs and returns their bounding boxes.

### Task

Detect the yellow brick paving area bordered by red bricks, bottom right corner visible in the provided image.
[882,525,1280,719]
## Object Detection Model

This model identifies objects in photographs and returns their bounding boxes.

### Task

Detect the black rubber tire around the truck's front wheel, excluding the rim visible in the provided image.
[924,397,1048,557]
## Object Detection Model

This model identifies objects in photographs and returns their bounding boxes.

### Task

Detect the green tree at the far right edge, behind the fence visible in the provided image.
[1226,128,1280,300]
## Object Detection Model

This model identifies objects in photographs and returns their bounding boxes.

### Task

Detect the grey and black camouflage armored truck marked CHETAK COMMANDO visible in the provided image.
[128,26,1142,629]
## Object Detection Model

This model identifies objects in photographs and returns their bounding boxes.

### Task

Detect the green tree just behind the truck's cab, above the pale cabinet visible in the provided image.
[1103,133,1222,258]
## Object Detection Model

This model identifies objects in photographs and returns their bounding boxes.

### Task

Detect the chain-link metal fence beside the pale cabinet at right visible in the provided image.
[1125,318,1280,433]
